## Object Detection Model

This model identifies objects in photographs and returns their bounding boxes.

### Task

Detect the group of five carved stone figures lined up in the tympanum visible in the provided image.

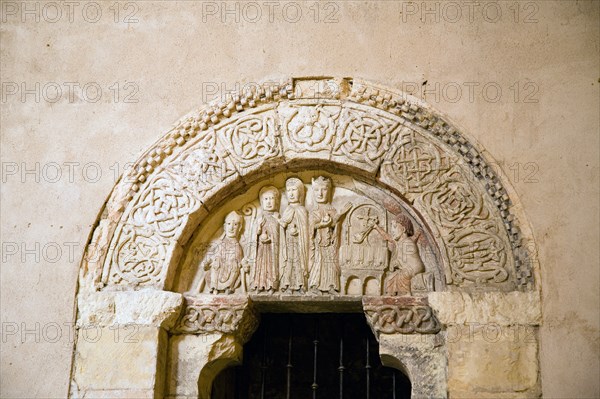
[201,176,425,295]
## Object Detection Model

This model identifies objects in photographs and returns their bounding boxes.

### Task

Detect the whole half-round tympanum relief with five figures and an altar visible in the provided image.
[198,176,437,296]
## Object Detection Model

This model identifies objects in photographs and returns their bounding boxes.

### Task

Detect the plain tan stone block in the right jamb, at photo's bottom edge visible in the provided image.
[447,325,541,398]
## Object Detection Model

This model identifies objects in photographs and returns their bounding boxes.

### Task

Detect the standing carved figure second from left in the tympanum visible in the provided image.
[250,186,280,293]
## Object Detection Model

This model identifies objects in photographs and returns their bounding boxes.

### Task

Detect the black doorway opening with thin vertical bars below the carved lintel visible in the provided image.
[212,313,411,399]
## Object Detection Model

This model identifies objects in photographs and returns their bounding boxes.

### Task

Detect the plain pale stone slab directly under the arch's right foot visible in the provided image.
[428,292,542,326]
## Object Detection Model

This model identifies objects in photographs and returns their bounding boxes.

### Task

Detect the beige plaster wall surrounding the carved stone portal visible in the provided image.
[0,1,600,398]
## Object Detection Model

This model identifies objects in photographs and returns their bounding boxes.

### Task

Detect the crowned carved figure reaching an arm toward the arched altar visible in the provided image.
[308,176,352,294]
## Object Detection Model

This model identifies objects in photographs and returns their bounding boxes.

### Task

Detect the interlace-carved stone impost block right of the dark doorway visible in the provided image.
[363,297,440,338]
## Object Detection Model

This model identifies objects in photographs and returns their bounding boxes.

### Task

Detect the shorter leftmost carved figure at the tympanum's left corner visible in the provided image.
[201,211,244,294]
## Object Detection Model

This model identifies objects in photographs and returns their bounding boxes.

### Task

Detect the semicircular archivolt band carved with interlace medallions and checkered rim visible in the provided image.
[82,79,533,294]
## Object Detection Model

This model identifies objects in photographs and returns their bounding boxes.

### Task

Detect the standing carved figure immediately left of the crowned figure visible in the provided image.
[279,177,308,292]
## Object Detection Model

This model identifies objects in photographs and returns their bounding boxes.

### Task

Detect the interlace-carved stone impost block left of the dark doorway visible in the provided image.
[173,295,259,343]
